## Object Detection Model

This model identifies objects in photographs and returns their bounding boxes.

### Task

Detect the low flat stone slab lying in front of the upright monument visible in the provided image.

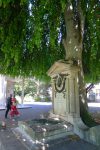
[18,118,73,143]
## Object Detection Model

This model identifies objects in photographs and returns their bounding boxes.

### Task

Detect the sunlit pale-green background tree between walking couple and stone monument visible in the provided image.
[14,78,50,103]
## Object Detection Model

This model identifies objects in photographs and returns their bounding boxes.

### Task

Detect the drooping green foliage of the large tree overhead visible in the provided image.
[0,0,100,81]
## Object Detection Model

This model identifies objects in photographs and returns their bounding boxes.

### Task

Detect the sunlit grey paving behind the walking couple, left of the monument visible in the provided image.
[0,102,52,121]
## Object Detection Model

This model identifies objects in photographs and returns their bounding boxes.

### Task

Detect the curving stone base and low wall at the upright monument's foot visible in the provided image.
[50,113,100,146]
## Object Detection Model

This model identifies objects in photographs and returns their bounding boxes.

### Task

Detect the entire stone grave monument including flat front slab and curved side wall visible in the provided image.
[12,61,100,146]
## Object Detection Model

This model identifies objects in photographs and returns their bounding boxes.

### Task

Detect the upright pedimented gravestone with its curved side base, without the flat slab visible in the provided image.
[47,60,100,145]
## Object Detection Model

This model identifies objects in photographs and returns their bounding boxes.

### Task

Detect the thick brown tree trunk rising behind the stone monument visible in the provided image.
[63,3,95,126]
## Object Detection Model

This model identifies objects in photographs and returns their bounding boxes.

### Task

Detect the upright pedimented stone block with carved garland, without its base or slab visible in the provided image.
[47,60,83,124]
